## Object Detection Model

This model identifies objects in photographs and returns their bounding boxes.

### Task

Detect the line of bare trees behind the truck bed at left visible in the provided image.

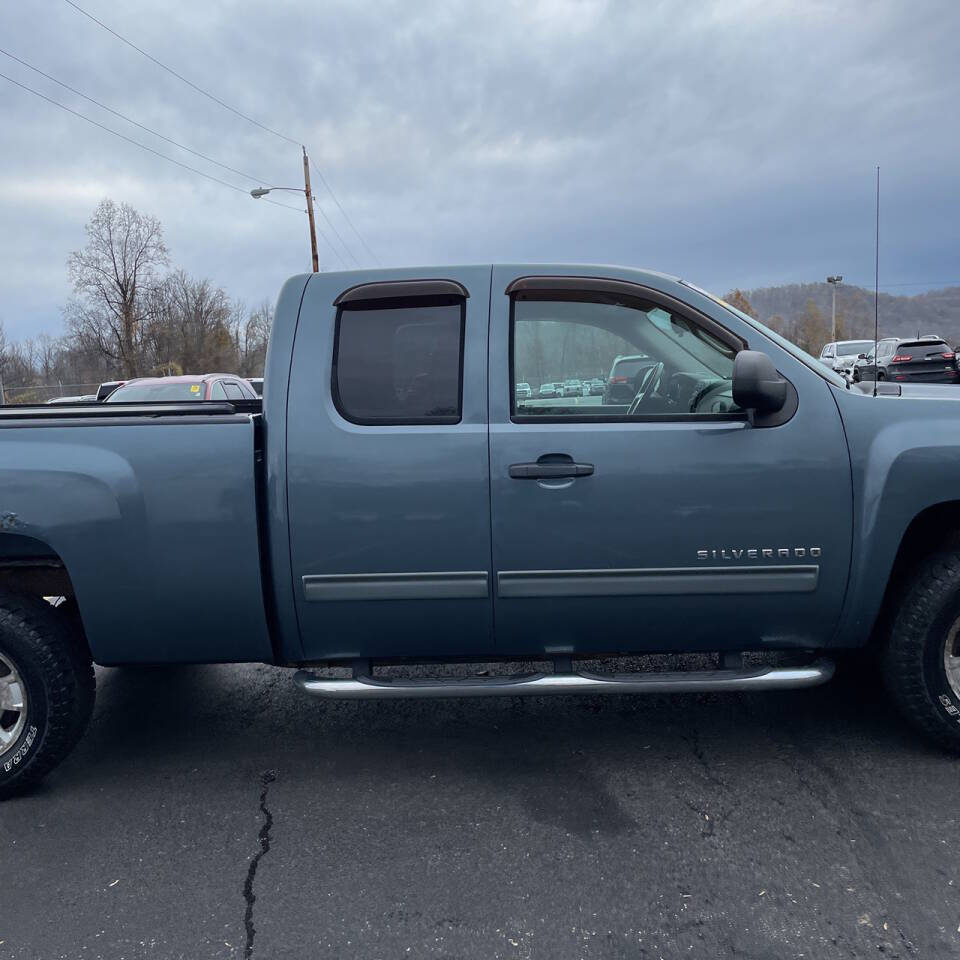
[0,199,273,403]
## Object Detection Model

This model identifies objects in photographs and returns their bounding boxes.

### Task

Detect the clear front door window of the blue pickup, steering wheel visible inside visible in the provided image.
[512,297,742,422]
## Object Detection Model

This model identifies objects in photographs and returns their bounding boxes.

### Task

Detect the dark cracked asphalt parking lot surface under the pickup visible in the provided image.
[0,666,960,960]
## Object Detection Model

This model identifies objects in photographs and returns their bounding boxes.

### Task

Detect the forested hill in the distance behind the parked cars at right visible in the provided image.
[738,283,960,352]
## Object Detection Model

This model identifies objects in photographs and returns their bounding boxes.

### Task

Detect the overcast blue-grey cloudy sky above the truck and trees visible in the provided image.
[0,0,960,337]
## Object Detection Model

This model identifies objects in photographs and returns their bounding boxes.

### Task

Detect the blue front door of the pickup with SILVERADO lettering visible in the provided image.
[490,267,851,654]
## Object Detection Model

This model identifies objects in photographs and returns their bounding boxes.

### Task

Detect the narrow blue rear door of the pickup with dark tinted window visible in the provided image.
[286,267,492,659]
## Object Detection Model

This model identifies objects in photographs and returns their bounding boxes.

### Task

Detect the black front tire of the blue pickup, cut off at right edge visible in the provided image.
[883,550,960,754]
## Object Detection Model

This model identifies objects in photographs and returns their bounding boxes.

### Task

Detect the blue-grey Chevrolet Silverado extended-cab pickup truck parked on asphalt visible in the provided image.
[0,265,960,795]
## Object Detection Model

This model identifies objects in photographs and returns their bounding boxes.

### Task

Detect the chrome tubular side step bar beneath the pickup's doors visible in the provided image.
[293,659,833,700]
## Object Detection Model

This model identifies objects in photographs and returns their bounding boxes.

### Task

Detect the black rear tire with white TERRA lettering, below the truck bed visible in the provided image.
[0,593,96,800]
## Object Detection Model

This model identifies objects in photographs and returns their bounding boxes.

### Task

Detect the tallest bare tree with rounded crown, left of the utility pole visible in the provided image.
[66,199,169,377]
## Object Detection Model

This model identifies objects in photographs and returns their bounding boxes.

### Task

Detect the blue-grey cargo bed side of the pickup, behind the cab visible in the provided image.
[0,401,271,664]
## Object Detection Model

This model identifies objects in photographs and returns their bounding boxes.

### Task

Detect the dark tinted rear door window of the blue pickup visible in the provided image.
[333,297,465,424]
